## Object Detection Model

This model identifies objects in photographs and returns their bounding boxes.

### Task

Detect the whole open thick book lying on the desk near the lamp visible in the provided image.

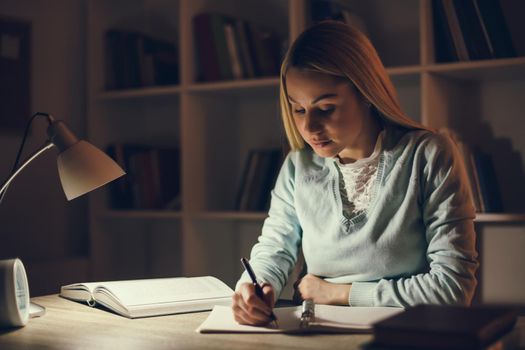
[60,276,233,318]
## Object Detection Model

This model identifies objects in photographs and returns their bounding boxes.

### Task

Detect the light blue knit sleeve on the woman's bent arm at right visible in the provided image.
[349,135,478,307]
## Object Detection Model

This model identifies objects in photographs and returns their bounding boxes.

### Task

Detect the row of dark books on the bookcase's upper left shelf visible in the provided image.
[104,29,179,90]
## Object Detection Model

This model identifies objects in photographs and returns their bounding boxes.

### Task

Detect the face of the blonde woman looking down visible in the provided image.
[286,68,370,158]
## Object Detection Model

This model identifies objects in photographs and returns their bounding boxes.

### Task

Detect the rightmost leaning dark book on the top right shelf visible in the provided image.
[472,0,516,58]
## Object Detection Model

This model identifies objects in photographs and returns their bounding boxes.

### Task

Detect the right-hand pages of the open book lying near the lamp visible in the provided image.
[95,276,233,307]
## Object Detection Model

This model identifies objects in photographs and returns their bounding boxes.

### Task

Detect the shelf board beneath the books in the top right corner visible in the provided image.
[423,57,525,81]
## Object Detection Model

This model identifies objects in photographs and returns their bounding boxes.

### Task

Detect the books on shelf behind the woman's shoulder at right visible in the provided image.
[441,129,503,213]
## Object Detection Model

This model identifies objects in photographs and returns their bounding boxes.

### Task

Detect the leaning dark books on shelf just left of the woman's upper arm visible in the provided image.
[235,148,283,211]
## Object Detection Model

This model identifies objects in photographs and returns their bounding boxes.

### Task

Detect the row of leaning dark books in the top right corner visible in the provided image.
[432,0,516,62]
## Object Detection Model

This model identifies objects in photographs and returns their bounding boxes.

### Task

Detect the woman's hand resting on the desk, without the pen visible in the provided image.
[294,274,352,305]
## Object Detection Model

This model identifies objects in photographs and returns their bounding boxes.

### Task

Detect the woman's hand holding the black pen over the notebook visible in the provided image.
[232,283,275,326]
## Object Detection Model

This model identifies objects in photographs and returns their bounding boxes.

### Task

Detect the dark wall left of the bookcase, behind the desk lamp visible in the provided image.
[0,0,88,295]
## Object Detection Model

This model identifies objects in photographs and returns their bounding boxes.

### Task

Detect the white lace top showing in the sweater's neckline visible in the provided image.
[336,131,384,217]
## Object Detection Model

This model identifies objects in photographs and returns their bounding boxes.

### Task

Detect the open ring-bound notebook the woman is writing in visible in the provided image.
[196,305,403,333]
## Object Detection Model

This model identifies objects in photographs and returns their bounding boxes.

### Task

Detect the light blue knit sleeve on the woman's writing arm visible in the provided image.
[236,152,301,297]
